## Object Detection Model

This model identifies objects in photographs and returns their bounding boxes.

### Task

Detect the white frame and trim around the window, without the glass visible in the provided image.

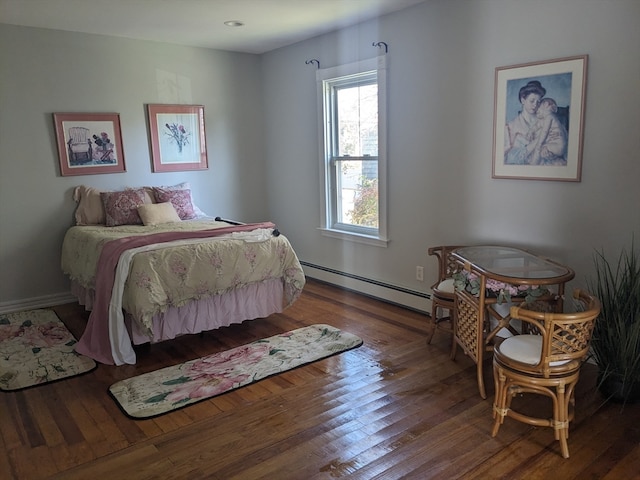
[316,55,388,247]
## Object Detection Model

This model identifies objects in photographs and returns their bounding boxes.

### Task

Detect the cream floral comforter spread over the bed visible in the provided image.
[61,220,305,329]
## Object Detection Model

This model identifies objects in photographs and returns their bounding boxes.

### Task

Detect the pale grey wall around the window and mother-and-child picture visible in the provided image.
[263,0,640,300]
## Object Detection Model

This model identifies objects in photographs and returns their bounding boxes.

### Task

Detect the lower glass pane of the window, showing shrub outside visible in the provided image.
[336,158,378,228]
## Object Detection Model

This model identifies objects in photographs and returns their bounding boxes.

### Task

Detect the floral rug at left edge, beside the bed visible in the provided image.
[0,309,96,391]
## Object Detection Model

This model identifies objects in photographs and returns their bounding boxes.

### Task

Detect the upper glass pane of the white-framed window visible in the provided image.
[336,83,378,157]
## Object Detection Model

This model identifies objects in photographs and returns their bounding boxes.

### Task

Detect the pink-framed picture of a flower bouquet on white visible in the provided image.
[147,104,209,172]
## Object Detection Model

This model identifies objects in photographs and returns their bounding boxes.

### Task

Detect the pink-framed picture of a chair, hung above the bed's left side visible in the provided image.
[53,113,126,177]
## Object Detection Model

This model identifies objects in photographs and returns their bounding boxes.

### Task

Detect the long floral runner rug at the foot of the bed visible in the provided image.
[109,325,362,418]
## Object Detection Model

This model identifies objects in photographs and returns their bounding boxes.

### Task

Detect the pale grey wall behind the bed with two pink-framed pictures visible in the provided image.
[0,24,267,306]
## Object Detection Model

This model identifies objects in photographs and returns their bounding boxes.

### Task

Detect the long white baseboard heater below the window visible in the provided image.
[300,261,431,313]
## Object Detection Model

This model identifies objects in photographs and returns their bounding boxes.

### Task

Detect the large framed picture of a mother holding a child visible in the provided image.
[492,55,587,182]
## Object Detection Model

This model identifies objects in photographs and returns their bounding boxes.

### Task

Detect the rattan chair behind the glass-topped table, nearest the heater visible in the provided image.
[427,245,461,343]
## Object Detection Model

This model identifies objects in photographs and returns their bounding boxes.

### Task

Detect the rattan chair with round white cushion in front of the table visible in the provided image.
[491,290,600,458]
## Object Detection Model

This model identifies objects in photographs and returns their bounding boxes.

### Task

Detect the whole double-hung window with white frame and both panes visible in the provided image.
[317,56,387,245]
